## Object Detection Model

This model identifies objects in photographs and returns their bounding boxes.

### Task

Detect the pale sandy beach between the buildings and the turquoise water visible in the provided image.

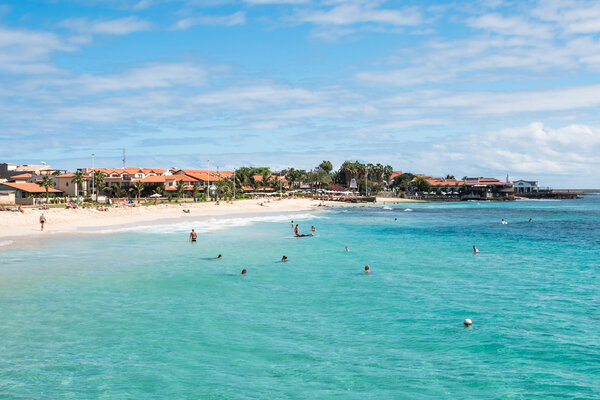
[0,199,321,243]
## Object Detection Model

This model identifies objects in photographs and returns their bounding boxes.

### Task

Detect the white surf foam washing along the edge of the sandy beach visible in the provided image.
[87,213,323,234]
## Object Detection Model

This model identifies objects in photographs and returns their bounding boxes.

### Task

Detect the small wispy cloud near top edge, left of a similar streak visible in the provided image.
[59,16,152,35]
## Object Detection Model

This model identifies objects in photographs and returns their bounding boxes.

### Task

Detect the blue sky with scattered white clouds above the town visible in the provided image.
[0,0,600,187]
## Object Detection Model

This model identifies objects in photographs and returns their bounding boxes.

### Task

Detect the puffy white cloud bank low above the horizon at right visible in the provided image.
[420,122,600,178]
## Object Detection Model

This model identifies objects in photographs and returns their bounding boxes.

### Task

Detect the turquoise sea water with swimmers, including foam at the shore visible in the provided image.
[0,196,600,399]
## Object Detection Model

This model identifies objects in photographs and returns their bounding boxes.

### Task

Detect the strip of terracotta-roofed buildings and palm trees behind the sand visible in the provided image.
[0,161,556,208]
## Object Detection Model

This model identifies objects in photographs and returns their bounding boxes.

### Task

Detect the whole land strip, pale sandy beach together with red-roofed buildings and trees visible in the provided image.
[0,161,572,240]
